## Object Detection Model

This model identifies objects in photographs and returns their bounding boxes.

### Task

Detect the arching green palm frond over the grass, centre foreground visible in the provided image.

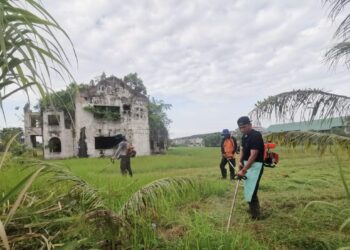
[121,177,196,217]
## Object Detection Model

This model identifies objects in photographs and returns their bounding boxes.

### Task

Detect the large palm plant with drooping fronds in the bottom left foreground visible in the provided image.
[0,137,198,250]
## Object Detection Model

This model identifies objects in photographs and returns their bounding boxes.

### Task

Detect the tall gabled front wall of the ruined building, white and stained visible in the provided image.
[76,78,150,157]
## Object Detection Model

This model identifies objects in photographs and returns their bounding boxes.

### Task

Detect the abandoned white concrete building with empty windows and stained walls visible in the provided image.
[24,76,151,159]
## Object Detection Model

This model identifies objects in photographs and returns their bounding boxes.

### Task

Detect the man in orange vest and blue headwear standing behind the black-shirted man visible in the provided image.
[220,129,237,180]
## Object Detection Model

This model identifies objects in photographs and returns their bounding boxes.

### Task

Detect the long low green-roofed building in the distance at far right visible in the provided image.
[267,117,350,136]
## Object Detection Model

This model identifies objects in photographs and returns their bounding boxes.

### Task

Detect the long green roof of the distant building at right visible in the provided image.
[267,117,347,132]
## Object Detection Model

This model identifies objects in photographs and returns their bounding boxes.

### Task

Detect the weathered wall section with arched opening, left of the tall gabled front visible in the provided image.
[43,111,76,159]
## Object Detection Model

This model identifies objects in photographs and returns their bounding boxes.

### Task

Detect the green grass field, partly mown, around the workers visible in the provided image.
[0,148,350,249]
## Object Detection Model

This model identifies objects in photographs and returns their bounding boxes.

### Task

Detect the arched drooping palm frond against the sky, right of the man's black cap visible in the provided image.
[249,89,350,121]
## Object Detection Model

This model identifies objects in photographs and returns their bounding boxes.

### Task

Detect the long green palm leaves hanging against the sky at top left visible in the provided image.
[0,0,75,116]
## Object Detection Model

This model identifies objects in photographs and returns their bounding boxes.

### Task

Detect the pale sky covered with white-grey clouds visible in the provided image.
[0,0,350,138]
